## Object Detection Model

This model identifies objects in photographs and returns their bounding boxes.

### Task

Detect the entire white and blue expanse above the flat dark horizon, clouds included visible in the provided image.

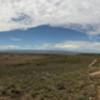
[0,0,100,53]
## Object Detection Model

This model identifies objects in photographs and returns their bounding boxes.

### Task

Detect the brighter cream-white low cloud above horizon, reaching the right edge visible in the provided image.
[36,41,100,53]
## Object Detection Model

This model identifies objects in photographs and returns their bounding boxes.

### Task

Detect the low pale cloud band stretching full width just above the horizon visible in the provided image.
[0,41,100,53]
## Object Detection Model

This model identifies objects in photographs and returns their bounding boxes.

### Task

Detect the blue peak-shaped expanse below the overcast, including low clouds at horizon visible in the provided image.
[0,25,100,53]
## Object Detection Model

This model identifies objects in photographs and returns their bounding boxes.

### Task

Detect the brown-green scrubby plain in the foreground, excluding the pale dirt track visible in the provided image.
[0,54,100,100]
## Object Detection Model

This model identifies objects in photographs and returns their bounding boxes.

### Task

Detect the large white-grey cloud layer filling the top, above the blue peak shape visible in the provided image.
[0,0,100,34]
